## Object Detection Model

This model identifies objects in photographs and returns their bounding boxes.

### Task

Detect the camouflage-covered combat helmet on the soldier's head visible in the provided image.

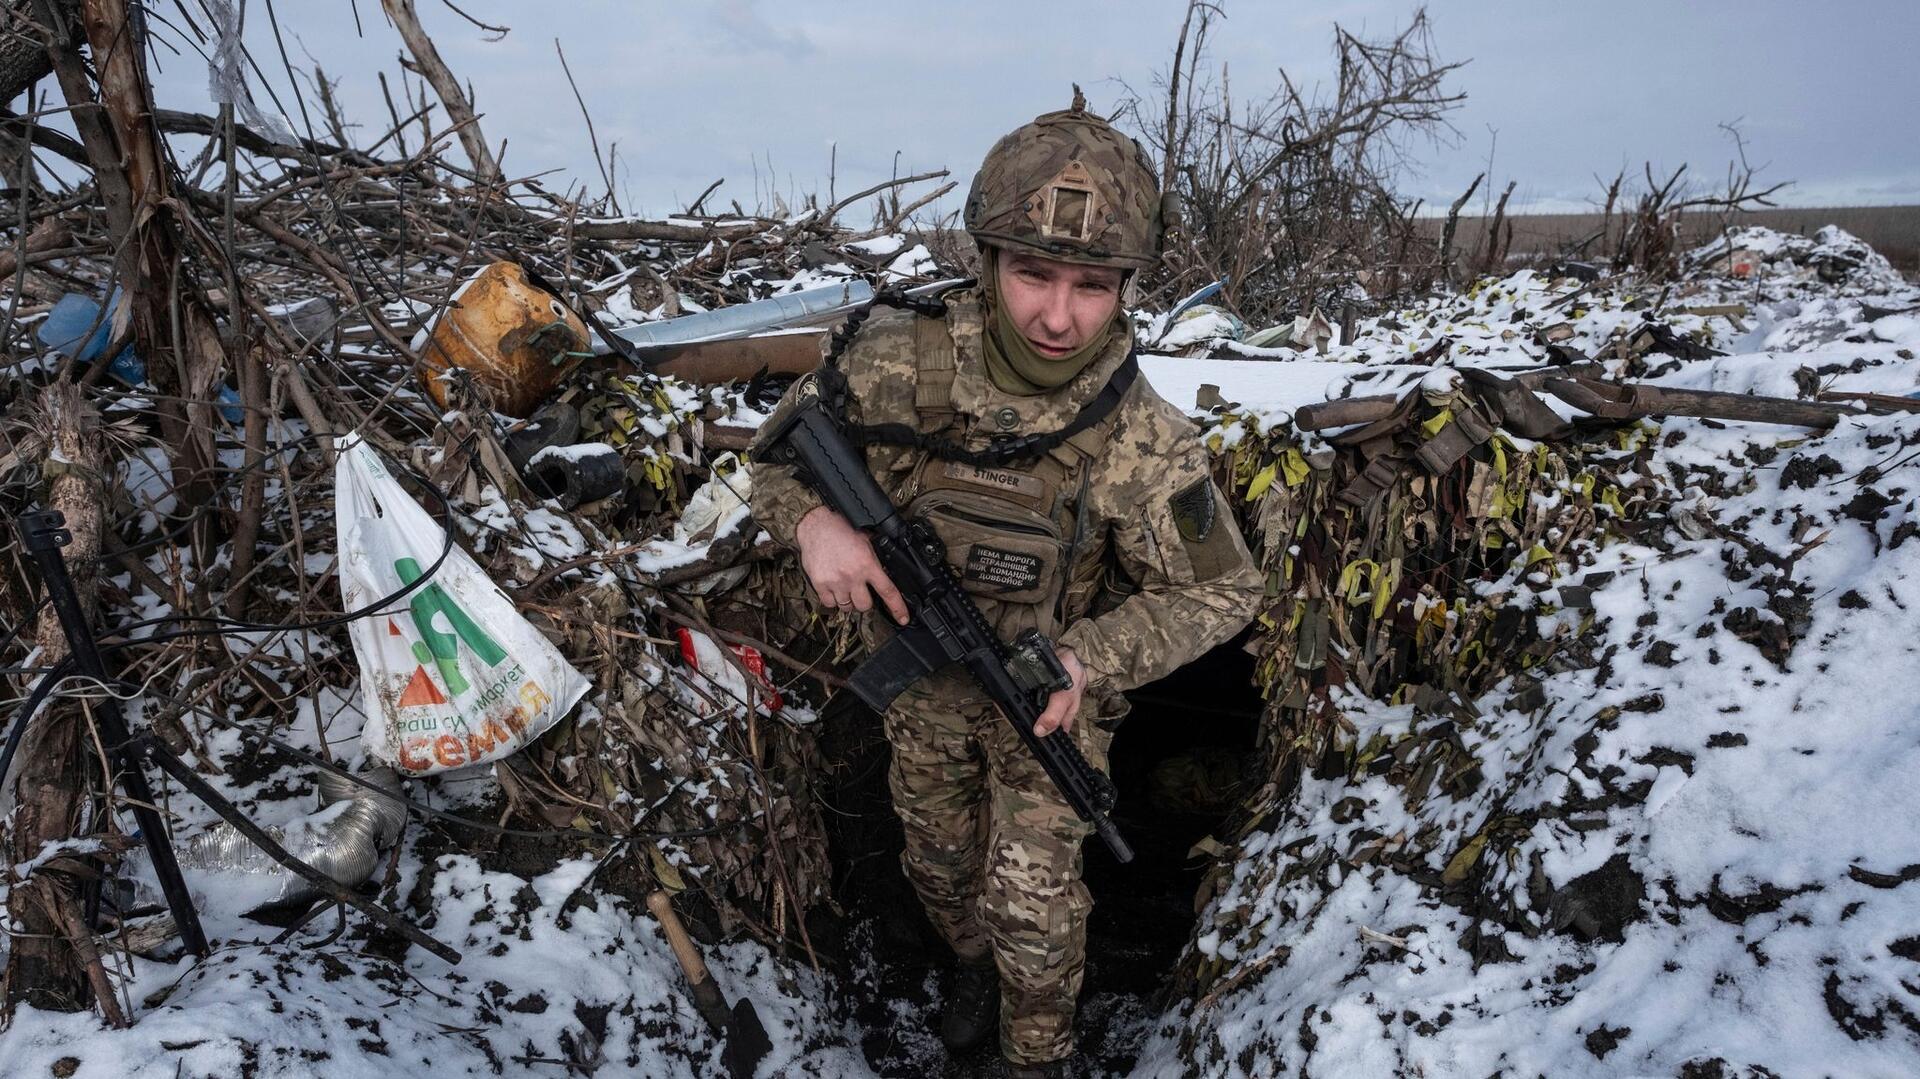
[966,86,1162,271]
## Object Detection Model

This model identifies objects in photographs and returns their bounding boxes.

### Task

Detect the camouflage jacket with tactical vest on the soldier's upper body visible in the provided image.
[753,290,1263,716]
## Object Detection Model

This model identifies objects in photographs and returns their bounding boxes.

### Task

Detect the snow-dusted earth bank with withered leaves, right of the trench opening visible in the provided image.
[1139,230,1920,1077]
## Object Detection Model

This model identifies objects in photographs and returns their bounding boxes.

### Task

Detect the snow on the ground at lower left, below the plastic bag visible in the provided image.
[0,854,860,1079]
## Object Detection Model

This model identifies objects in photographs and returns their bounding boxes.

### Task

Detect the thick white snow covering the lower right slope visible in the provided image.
[1140,433,1920,1075]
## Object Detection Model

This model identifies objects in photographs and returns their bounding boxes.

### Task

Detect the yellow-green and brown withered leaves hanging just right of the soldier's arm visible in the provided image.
[1181,380,1665,993]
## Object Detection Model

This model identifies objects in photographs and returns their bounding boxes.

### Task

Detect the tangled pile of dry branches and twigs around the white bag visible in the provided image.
[0,10,952,998]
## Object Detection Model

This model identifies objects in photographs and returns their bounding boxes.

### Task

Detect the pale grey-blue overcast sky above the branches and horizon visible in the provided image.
[135,0,1920,215]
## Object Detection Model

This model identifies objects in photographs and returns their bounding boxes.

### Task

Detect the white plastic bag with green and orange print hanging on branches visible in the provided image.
[334,440,588,776]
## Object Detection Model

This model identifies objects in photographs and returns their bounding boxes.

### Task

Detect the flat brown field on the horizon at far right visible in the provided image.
[1421,205,1920,275]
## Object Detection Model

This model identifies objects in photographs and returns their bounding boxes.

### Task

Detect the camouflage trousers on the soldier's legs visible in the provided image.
[887,672,1112,1064]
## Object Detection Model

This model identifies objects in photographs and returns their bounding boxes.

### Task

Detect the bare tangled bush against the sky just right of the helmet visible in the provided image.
[1119,2,1461,324]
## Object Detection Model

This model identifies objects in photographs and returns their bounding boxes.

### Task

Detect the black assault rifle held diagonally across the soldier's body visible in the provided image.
[766,374,1133,862]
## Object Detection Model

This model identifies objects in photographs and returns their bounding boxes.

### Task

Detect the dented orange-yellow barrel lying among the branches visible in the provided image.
[419,261,588,417]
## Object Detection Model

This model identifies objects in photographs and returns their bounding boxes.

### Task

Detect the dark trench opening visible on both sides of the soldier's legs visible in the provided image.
[810,635,1260,1079]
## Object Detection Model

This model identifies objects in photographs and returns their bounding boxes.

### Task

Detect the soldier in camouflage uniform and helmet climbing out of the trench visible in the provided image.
[753,88,1261,1075]
